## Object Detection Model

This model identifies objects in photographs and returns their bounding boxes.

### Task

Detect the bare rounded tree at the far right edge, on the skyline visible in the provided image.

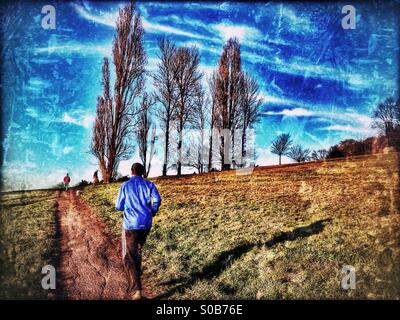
[372,98,400,135]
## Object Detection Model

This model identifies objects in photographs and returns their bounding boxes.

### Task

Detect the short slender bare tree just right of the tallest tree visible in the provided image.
[135,93,156,178]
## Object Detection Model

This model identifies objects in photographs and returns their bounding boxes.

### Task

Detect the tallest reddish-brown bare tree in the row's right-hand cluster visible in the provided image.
[215,39,243,170]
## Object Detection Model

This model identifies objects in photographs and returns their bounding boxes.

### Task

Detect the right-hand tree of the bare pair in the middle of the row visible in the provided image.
[173,47,202,176]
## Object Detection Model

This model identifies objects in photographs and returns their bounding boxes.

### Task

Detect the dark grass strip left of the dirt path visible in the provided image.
[0,191,57,299]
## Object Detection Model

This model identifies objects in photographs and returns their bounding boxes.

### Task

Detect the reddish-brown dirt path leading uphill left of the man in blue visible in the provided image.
[54,190,129,300]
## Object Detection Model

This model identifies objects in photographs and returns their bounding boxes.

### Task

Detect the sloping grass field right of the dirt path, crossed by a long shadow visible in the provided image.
[83,153,400,299]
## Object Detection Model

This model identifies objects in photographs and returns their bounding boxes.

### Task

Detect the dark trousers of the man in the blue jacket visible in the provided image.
[121,229,150,292]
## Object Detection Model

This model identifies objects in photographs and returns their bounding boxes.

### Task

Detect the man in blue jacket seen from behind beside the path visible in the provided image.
[115,163,161,300]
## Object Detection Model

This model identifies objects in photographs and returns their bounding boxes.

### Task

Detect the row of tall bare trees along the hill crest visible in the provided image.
[90,3,261,183]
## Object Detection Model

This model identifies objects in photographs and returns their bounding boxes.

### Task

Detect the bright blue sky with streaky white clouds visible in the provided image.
[2,1,399,189]
